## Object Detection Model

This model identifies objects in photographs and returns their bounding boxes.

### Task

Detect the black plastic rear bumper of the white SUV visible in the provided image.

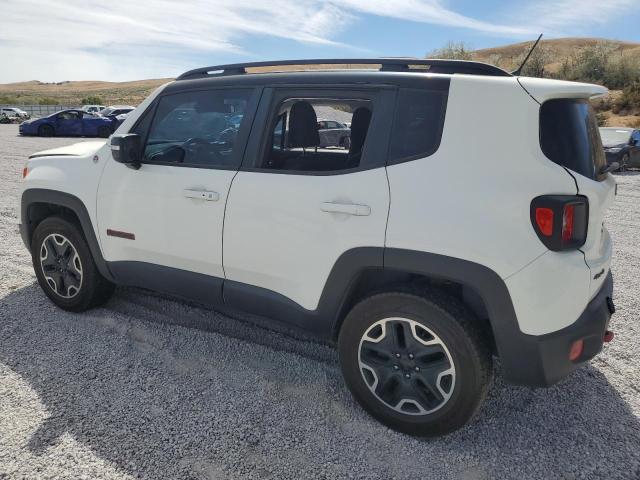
[503,272,615,387]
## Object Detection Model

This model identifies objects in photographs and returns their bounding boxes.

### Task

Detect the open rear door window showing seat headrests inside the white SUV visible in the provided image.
[262,98,373,172]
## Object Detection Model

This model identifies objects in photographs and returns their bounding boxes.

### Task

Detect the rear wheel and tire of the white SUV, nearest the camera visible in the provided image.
[338,292,493,437]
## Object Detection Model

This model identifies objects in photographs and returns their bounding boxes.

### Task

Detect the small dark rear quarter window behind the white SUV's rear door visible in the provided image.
[389,88,447,163]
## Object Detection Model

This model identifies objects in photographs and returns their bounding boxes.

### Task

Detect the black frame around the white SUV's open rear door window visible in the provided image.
[240,85,397,176]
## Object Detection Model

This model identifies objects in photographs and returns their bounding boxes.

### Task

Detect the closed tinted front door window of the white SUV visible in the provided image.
[144,90,252,167]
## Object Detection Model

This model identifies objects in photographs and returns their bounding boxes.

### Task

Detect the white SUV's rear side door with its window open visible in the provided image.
[224,87,395,310]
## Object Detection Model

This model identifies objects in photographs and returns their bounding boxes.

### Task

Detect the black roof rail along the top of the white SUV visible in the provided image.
[176,58,511,80]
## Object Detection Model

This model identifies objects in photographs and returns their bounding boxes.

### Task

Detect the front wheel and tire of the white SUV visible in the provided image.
[31,217,115,312]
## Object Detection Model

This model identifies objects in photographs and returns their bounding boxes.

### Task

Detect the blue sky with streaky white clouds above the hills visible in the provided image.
[0,0,640,83]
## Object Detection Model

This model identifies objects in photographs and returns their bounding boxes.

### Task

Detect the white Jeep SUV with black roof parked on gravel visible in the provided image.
[19,59,616,435]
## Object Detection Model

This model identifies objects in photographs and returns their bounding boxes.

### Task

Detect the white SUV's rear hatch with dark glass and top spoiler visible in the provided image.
[519,78,616,297]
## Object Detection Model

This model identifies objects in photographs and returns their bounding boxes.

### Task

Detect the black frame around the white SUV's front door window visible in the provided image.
[134,85,262,171]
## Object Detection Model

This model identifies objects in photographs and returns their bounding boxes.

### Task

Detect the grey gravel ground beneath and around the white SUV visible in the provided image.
[0,125,640,479]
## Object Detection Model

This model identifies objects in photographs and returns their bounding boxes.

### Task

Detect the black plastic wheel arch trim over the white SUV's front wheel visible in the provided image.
[20,188,113,281]
